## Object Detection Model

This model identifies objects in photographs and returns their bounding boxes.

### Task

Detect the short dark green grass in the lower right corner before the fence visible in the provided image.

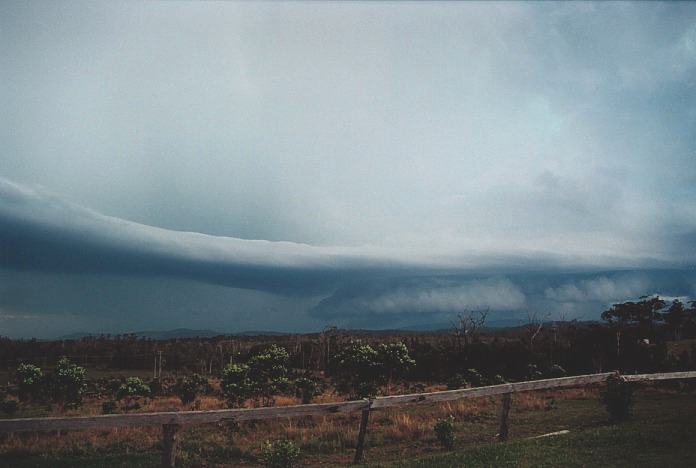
[374,397,696,468]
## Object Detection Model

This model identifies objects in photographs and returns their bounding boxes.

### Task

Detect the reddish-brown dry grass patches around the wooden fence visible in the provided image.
[0,386,608,465]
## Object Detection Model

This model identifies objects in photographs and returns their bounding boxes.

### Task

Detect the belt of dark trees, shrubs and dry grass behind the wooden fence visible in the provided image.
[0,297,696,466]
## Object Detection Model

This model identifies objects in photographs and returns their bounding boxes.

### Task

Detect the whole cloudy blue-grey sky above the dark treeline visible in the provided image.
[0,1,696,337]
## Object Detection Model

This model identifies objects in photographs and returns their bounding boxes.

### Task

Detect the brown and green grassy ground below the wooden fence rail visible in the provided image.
[0,388,696,468]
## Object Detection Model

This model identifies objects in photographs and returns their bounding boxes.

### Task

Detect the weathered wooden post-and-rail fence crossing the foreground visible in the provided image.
[0,371,696,468]
